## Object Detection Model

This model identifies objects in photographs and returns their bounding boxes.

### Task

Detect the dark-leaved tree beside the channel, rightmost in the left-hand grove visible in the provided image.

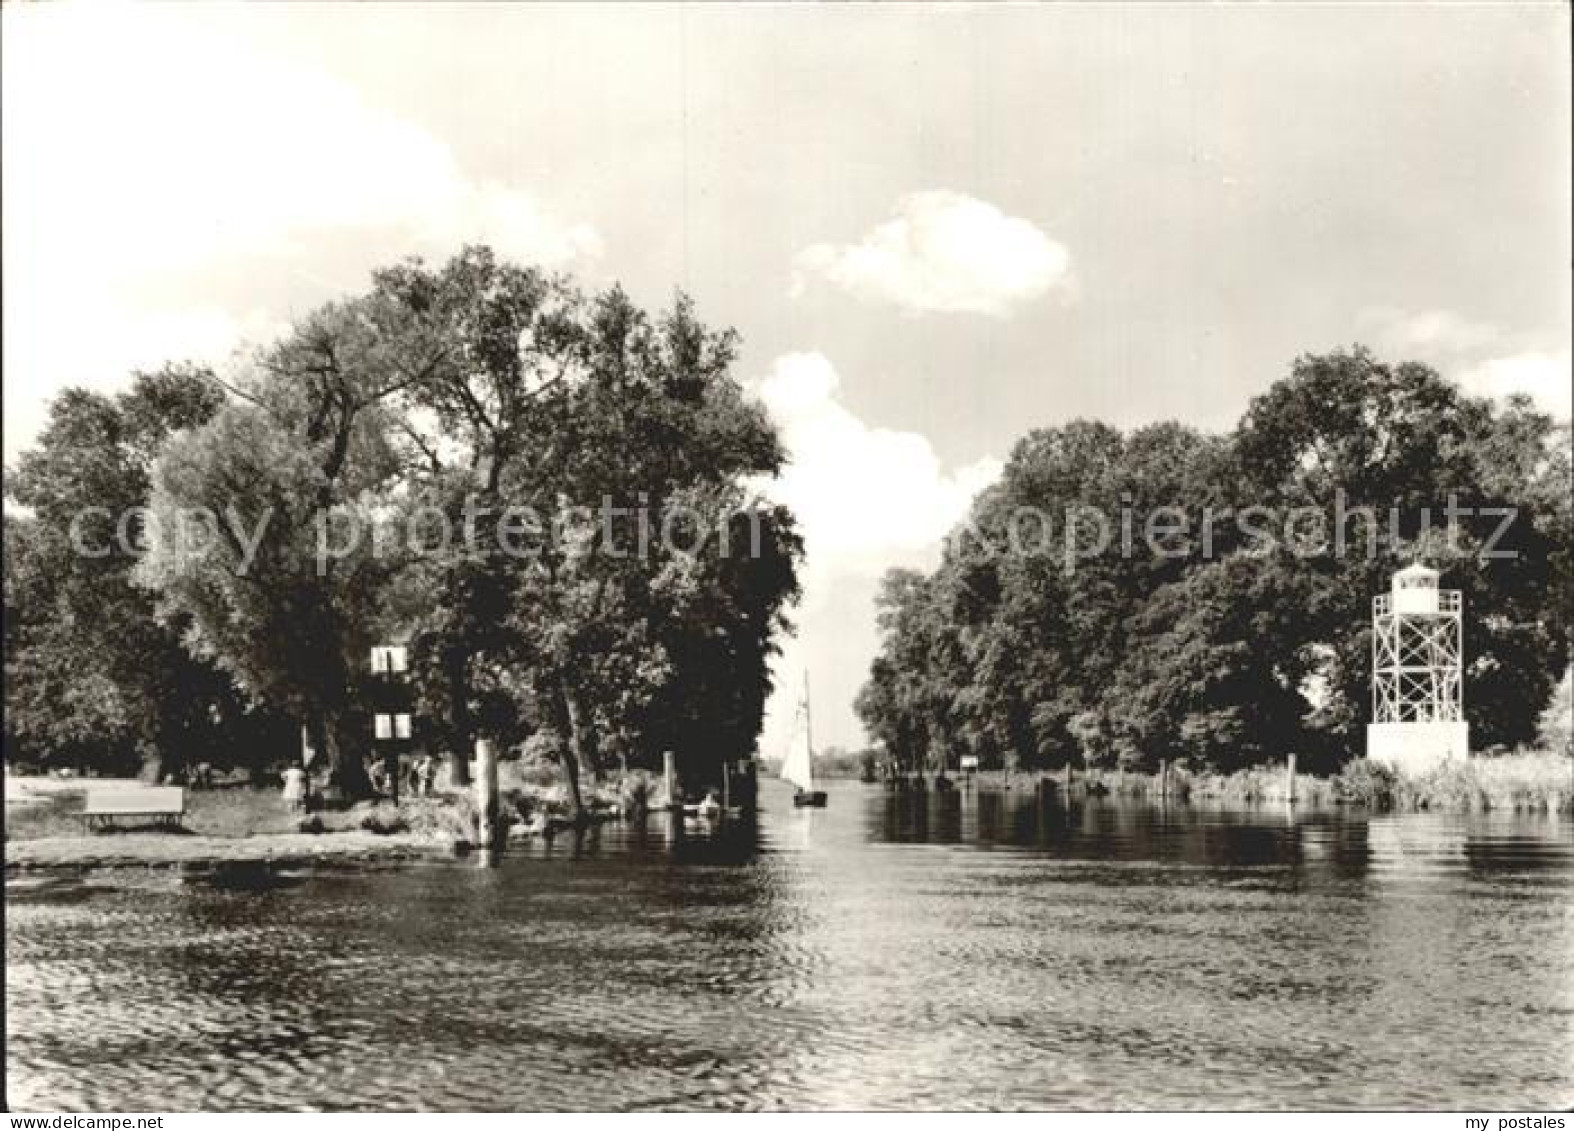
[503,289,798,805]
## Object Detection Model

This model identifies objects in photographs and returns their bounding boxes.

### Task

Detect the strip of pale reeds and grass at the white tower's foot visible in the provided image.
[1073,750,1574,813]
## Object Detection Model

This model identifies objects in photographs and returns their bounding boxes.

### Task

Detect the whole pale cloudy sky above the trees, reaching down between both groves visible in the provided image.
[0,3,1571,755]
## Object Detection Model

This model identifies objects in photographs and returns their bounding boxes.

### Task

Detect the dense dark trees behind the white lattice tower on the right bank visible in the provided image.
[858,348,1574,771]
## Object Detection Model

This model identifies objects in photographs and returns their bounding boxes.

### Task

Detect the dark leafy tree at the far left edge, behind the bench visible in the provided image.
[5,367,261,772]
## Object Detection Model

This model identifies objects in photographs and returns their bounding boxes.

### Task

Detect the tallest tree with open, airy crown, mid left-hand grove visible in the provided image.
[365,247,584,796]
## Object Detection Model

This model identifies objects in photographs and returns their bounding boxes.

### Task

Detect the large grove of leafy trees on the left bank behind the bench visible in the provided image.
[5,249,801,802]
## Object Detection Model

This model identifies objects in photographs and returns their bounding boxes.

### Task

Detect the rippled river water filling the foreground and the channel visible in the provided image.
[5,782,1574,1111]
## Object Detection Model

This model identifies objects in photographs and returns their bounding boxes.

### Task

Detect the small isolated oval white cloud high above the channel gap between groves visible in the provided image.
[793,190,1073,318]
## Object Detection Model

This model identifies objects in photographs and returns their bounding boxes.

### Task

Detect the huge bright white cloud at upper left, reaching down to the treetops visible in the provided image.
[3,5,600,453]
